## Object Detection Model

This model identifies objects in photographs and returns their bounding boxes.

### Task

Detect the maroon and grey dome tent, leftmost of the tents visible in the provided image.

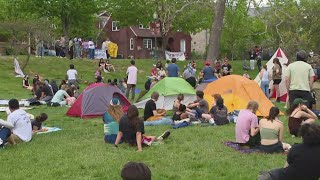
[67,83,130,118]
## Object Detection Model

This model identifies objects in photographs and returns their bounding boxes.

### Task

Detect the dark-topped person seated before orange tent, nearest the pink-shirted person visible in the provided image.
[202,95,229,126]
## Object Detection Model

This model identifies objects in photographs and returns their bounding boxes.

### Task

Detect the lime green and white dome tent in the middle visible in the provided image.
[135,77,196,110]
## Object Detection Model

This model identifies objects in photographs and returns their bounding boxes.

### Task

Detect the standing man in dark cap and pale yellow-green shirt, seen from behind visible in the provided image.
[285,50,315,108]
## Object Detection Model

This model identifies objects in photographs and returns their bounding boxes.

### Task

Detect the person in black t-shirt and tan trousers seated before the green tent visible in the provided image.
[144,91,172,126]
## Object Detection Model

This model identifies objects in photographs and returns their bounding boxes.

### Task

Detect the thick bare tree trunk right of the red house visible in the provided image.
[207,0,226,62]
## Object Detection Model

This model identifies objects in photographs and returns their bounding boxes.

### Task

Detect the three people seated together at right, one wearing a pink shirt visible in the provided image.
[236,98,317,153]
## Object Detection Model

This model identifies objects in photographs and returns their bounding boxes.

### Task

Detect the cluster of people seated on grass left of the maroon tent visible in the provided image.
[23,74,79,106]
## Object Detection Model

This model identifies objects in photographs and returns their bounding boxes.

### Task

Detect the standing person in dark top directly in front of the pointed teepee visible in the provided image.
[270,58,282,102]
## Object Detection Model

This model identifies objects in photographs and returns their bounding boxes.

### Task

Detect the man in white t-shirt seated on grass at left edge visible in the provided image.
[0,99,32,148]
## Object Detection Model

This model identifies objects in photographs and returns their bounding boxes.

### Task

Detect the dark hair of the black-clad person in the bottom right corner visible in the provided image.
[299,123,320,145]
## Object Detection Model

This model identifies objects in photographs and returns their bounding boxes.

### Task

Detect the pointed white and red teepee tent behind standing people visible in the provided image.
[254,48,288,101]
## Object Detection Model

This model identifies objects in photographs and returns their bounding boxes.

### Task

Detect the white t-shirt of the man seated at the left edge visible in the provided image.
[7,109,32,142]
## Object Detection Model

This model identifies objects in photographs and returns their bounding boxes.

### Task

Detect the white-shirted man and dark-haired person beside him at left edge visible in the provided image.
[0,99,48,148]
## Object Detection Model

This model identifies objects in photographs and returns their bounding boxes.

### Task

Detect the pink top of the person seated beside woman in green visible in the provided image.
[236,109,258,143]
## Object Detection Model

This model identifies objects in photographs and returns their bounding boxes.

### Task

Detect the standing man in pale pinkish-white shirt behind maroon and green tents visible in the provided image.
[126,60,138,100]
